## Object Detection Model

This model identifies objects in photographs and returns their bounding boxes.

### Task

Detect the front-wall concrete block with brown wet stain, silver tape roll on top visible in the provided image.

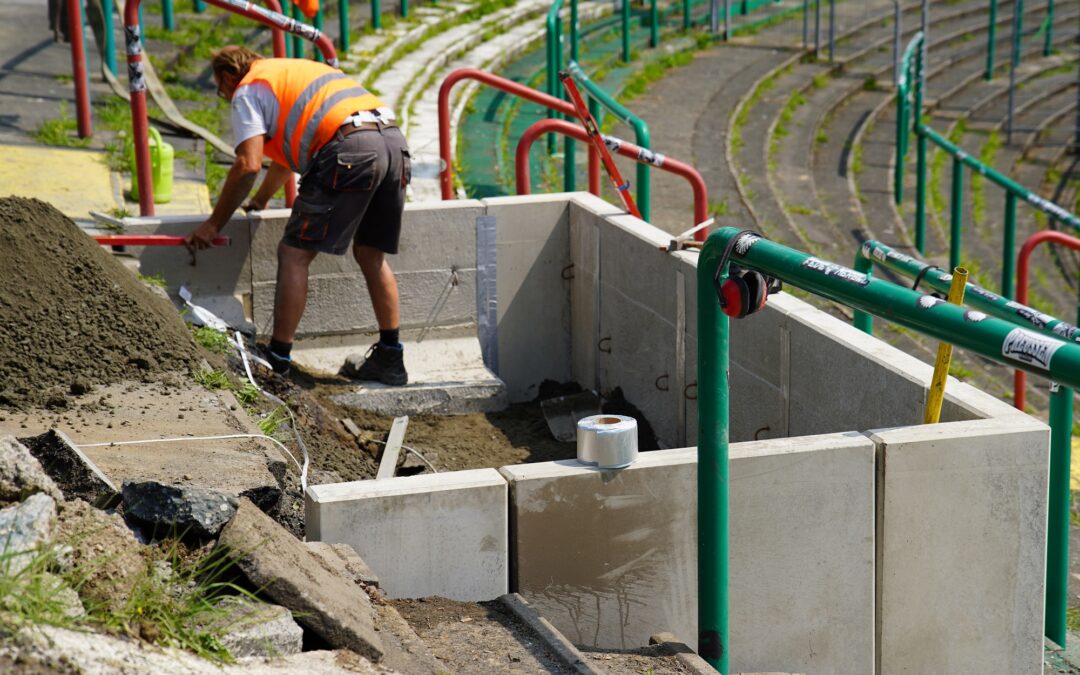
[500,433,874,675]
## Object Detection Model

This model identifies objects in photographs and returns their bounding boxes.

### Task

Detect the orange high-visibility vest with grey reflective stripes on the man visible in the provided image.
[240,58,382,174]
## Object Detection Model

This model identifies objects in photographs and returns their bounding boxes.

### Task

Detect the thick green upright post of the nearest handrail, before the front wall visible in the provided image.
[695,228,738,675]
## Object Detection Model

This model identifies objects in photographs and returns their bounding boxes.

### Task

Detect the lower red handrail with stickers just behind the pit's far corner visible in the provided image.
[514,120,708,236]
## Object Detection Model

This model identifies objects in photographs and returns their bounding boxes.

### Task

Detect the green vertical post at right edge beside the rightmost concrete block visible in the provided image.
[1043,382,1072,647]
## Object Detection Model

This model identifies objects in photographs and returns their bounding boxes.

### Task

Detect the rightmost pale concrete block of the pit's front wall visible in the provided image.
[868,415,1050,675]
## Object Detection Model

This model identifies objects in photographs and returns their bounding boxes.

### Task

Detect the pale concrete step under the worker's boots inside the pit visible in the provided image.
[293,332,508,416]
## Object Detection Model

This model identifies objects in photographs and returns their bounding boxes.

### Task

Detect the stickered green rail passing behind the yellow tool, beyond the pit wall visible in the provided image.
[856,240,1080,346]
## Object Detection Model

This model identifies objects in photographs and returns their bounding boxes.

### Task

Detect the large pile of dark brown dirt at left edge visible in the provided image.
[0,197,195,409]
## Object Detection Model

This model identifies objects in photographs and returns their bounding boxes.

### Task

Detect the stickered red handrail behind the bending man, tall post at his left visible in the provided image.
[124,0,338,216]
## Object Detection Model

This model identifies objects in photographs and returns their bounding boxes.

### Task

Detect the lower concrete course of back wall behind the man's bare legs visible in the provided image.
[253,269,476,337]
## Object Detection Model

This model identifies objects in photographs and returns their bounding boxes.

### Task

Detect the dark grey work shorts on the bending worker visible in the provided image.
[282,125,413,255]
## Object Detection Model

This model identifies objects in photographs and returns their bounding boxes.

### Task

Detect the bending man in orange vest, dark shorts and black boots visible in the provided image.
[186,45,411,384]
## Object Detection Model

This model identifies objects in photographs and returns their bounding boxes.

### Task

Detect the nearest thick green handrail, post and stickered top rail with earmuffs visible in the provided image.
[698,228,1080,673]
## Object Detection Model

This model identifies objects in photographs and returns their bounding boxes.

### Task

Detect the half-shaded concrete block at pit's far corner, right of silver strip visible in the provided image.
[484,195,571,402]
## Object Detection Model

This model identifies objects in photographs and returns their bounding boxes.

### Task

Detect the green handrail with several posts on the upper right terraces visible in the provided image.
[893,33,1080,298]
